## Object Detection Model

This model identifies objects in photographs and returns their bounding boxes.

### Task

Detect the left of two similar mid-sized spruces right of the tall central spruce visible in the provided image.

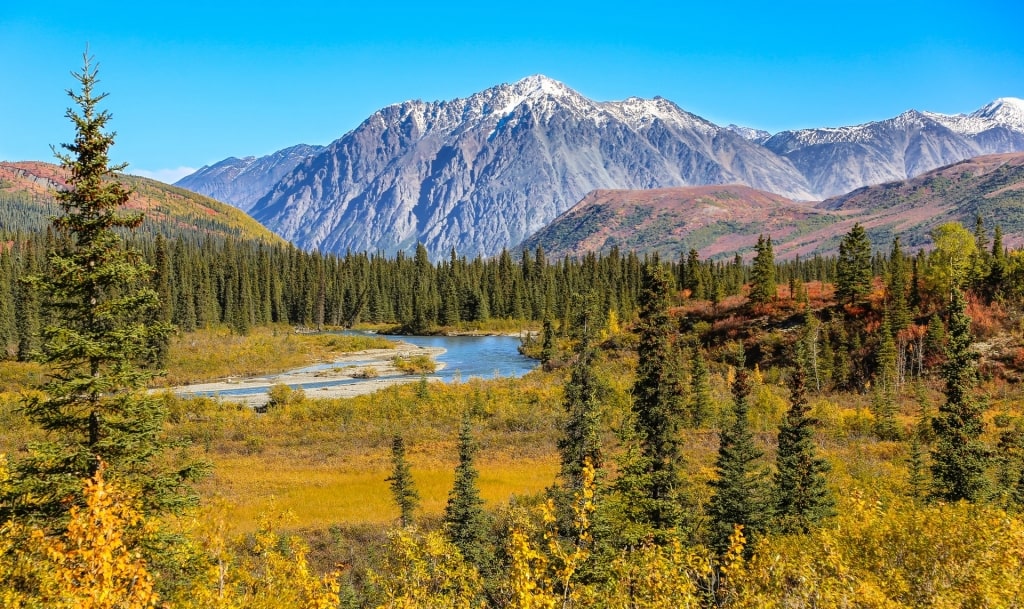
[708,368,770,554]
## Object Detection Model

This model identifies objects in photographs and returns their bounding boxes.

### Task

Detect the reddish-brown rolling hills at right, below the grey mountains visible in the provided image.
[522,153,1024,259]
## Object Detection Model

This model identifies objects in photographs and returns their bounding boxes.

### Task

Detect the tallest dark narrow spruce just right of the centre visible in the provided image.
[633,262,683,540]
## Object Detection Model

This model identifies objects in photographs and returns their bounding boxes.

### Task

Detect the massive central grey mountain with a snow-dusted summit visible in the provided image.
[243,76,814,257]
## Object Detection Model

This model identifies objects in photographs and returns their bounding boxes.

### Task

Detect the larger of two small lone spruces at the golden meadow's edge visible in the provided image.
[443,415,494,572]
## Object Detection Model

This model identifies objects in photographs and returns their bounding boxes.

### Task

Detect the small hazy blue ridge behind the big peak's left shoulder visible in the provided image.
[174,144,324,212]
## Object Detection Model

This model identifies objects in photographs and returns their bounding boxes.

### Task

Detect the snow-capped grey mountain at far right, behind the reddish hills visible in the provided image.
[764,97,1024,198]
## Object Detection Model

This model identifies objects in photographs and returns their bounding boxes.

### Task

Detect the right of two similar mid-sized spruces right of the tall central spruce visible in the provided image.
[774,354,835,532]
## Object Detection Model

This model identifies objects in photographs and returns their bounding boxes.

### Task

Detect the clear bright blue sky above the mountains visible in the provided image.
[0,0,1024,181]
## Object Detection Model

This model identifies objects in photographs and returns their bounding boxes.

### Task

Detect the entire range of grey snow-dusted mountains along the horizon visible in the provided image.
[165,76,1024,258]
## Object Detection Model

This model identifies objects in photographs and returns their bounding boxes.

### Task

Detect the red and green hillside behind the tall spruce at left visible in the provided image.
[0,162,282,243]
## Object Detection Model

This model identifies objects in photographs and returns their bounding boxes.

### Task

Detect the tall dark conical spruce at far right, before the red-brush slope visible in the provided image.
[932,289,989,502]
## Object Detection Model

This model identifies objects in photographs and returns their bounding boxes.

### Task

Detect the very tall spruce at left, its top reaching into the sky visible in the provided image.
[10,53,202,519]
